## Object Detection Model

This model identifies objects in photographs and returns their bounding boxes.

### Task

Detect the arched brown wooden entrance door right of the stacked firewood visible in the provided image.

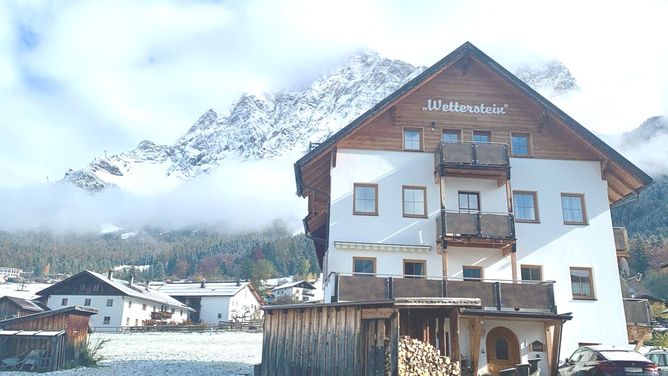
[486,326,520,374]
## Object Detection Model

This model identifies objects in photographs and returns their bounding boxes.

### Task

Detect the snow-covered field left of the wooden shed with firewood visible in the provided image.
[0,332,262,376]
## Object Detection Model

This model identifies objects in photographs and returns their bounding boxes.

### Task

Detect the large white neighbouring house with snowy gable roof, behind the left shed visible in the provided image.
[37,270,193,331]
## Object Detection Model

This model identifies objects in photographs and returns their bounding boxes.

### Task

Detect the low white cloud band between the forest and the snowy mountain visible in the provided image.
[0,159,306,233]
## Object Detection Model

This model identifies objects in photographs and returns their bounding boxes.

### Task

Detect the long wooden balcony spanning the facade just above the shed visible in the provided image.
[332,273,557,313]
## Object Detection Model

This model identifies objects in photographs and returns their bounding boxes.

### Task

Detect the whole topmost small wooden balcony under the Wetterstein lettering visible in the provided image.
[434,141,510,186]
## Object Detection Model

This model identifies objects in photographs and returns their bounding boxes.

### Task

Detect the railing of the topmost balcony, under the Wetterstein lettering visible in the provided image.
[434,141,510,179]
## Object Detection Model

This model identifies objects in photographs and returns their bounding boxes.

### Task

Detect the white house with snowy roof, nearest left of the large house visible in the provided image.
[157,281,262,324]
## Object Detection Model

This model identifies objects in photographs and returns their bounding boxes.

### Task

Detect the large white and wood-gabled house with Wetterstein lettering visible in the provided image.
[295,43,652,374]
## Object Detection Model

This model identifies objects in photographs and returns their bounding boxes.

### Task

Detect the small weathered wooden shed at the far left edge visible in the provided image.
[0,306,97,370]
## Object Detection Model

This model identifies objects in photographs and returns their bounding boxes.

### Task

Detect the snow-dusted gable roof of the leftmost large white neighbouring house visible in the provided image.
[37,270,193,311]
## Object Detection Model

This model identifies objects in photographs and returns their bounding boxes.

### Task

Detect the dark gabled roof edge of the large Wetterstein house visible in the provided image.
[294,42,653,196]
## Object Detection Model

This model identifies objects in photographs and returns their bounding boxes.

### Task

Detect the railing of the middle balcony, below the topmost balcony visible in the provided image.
[436,209,515,240]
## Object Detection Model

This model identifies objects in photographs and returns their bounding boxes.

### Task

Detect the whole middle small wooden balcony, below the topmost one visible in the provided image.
[436,210,515,252]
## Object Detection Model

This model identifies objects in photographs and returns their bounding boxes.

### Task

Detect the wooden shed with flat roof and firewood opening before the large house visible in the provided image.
[260,298,480,376]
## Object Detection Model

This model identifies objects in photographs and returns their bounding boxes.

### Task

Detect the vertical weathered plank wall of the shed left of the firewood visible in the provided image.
[260,306,398,376]
